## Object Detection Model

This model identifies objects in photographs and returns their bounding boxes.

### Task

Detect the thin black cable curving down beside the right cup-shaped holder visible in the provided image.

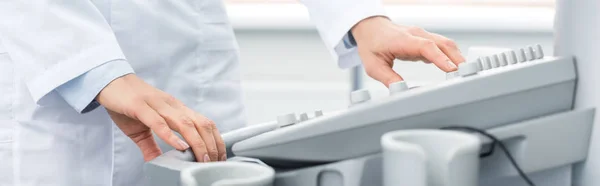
[442,126,535,186]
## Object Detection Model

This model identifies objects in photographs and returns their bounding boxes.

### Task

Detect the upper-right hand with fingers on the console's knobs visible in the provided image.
[352,17,465,87]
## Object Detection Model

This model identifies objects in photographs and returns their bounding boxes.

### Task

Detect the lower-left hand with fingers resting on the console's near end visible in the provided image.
[96,74,226,162]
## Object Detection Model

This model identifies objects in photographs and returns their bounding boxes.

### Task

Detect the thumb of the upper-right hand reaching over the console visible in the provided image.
[363,53,403,87]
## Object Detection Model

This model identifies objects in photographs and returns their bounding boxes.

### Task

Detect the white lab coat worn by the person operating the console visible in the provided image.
[0,0,382,186]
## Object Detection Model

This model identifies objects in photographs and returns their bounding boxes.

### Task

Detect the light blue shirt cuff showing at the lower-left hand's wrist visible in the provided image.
[56,60,133,113]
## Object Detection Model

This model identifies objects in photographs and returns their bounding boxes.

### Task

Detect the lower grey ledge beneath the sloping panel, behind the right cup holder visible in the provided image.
[275,109,594,186]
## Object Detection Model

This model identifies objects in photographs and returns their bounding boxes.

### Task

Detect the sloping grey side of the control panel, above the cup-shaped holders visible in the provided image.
[233,57,576,166]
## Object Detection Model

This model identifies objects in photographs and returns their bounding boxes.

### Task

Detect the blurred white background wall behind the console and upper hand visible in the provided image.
[228,4,554,124]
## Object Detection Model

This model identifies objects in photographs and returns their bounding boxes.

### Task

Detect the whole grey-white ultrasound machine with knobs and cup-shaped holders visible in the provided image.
[144,0,600,186]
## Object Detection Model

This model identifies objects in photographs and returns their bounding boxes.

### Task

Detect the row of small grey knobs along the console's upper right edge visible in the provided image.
[446,44,544,79]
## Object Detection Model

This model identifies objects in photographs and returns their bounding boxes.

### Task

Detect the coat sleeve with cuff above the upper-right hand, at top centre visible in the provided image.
[300,0,385,68]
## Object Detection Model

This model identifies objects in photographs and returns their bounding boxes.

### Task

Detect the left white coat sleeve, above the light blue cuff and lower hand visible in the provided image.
[0,0,130,104]
